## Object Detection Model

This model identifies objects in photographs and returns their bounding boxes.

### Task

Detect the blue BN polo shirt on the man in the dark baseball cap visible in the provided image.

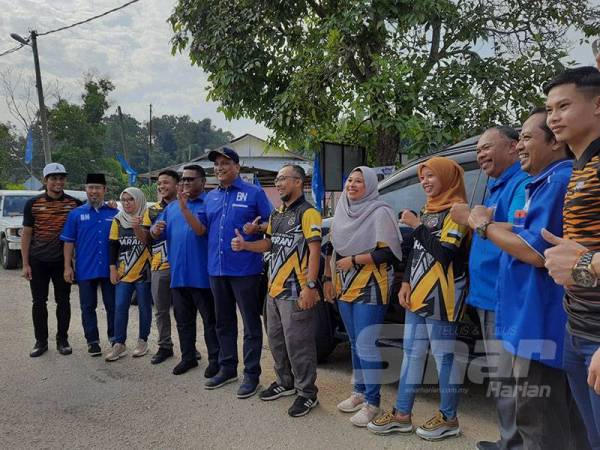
[202,177,272,277]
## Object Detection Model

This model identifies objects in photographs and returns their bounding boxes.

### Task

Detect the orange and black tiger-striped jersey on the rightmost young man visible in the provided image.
[563,139,600,342]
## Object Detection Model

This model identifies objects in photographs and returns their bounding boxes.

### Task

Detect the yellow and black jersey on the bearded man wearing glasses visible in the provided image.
[266,196,321,300]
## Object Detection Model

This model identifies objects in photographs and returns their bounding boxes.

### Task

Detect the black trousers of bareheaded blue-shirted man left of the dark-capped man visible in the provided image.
[171,287,219,363]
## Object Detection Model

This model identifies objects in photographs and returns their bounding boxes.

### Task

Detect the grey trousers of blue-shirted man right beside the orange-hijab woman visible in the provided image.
[477,308,522,449]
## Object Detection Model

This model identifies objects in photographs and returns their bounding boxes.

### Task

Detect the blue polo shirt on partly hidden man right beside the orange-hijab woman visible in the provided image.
[467,162,530,311]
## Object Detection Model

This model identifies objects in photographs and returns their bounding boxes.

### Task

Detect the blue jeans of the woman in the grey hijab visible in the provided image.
[337,300,387,406]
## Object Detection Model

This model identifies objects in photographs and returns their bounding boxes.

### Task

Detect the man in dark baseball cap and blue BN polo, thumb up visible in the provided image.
[203,147,272,398]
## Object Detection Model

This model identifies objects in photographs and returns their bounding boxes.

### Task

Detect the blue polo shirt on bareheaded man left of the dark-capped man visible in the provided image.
[162,193,210,288]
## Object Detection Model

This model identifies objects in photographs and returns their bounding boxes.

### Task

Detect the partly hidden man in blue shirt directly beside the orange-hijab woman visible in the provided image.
[450,126,529,450]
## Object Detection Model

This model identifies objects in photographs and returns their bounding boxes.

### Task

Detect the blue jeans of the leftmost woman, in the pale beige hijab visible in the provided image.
[115,281,152,344]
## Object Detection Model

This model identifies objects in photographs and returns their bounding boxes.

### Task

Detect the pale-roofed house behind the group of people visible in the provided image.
[138,134,313,205]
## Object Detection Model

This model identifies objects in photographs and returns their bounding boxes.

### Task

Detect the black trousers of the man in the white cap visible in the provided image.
[29,258,71,342]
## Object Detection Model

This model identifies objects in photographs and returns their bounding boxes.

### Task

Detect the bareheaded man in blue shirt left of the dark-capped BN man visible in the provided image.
[150,164,219,378]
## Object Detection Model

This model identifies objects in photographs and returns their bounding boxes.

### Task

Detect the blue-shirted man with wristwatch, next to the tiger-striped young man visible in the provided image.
[469,108,587,449]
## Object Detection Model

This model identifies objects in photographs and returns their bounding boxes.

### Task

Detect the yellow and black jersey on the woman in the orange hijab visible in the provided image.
[404,210,470,322]
